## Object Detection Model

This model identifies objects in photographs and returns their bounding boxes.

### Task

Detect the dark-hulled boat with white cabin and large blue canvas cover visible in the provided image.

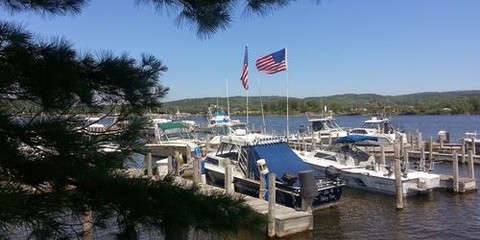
[204,131,344,210]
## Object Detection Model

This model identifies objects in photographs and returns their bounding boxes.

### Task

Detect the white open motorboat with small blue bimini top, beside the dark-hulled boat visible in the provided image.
[296,135,440,196]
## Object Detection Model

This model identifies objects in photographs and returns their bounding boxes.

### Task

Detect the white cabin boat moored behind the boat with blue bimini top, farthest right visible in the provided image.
[349,117,407,145]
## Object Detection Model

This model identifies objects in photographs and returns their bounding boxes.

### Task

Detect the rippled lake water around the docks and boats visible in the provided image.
[196,116,480,240]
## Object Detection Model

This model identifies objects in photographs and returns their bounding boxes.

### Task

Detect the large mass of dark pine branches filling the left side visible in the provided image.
[0,18,263,239]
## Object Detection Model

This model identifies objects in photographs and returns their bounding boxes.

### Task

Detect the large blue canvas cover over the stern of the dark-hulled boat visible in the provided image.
[249,142,312,185]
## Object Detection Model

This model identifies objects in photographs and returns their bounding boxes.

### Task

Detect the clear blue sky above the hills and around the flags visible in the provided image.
[0,0,480,101]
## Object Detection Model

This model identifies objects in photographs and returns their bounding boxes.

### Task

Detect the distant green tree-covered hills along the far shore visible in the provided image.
[160,90,480,115]
